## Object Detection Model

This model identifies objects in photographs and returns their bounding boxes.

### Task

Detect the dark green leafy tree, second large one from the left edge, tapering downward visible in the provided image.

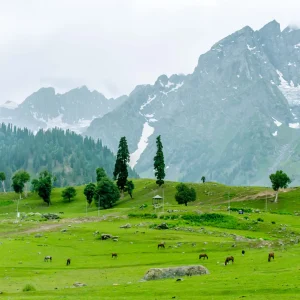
[31,171,55,206]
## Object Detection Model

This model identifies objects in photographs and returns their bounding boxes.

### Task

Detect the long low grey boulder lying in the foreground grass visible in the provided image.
[143,265,209,280]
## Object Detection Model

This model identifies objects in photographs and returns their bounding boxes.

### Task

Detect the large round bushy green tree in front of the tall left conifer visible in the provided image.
[94,177,120,209]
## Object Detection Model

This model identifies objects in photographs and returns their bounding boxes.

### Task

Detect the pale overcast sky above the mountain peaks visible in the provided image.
[0,0,300,103]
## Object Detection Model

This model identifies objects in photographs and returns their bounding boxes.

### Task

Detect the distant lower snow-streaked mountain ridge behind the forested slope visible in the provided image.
[0,86,127,133]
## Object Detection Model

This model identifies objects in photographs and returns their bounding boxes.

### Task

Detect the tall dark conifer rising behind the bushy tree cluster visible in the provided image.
[114,136,130,197]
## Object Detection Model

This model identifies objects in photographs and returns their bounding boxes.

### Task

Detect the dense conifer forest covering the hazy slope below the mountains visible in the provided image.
[0,123,138,190]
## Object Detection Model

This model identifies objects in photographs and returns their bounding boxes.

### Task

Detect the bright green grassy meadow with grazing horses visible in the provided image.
[0,179,300,300]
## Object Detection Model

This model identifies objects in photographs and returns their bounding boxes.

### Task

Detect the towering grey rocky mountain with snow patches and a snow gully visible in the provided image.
[85,21,300,184]
